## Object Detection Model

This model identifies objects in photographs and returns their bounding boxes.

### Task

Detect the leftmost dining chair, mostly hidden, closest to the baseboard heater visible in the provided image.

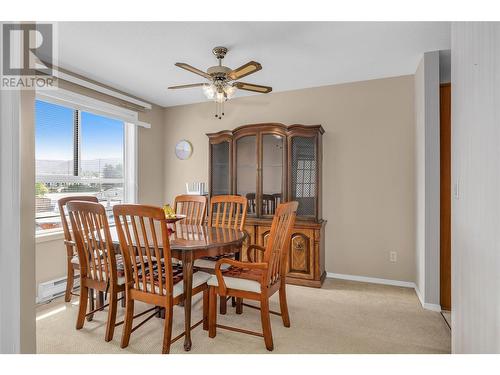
[57,195,98,303]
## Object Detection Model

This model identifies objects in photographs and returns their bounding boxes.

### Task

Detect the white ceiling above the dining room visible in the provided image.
[58,22,450,106]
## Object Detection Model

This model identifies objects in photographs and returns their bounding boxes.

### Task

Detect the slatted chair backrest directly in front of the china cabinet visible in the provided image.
[208,195,248,230]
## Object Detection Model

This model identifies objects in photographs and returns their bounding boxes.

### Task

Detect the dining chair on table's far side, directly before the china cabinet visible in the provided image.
[194,195,248,314]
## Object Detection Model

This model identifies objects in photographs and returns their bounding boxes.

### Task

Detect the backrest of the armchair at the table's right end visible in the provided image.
[264,202,299,285]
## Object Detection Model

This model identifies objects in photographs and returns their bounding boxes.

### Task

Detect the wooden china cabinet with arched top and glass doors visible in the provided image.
[207,123,326,287]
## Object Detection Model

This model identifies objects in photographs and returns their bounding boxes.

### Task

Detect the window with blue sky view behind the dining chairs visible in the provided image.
[35,99,135,235]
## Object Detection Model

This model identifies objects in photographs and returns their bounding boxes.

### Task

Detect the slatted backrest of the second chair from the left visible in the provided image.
[66,201,117,285]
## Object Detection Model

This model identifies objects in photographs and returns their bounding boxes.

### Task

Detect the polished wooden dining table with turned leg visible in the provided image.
[110,222,246,351]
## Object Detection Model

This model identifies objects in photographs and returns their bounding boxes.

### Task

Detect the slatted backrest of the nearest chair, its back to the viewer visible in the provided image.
[113,204,173,297]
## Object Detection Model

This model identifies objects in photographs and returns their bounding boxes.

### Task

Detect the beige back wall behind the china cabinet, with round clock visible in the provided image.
[164,76,415,281]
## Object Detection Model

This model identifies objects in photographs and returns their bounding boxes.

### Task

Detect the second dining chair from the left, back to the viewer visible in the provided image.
[66,201,125,341]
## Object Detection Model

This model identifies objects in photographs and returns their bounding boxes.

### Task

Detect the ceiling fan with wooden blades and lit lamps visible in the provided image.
[169,47,272,119]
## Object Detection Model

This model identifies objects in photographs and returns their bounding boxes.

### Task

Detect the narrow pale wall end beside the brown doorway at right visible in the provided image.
[415,51,440,309]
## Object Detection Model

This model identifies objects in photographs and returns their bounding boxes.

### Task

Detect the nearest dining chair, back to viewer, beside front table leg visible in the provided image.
[113,204,210,354]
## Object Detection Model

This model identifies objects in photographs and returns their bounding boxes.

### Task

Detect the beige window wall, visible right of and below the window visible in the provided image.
[36,106,165,292]
